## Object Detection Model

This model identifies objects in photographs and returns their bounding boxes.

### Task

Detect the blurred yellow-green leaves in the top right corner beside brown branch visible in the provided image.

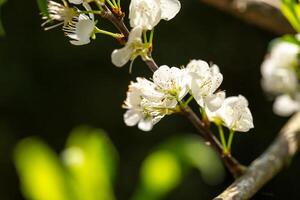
[281,0,300,32]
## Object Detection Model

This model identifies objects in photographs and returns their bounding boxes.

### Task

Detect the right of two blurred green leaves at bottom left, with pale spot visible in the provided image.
[62,127,118,200]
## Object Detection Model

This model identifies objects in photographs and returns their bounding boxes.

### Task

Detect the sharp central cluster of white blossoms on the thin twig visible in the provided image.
[124,60,253,132]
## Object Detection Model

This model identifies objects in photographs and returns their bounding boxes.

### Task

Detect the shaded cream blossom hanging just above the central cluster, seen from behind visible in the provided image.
[111,27,148,67]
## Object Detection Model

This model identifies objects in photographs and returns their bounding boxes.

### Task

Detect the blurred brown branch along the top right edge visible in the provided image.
[200,0,295,35]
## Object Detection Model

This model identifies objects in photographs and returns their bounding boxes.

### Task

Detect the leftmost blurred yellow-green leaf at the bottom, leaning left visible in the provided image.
[14,138,74,200]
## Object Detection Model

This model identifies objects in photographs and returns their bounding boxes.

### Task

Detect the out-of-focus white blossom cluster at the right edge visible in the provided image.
[261,37,300,116]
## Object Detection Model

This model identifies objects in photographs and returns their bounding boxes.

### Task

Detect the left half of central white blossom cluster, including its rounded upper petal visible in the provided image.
[123,65,188,131]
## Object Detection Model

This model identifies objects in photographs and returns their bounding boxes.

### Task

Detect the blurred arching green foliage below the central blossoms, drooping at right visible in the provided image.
[132,135,224,200]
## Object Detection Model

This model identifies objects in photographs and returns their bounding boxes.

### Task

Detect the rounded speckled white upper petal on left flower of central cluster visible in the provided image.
[153,65,189,101]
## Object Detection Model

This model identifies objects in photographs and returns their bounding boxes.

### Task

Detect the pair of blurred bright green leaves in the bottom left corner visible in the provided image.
[15,127,117,200]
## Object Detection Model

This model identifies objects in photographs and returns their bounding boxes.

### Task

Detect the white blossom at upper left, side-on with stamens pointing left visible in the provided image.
[63,14,95,45]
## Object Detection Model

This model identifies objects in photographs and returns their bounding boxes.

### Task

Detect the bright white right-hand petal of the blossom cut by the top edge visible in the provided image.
[160,0,181,20]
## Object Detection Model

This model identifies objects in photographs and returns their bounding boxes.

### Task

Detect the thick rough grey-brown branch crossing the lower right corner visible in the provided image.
[215,112,300,200]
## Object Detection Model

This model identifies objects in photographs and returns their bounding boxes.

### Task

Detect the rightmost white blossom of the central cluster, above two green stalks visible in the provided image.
[206,95,254,132]
